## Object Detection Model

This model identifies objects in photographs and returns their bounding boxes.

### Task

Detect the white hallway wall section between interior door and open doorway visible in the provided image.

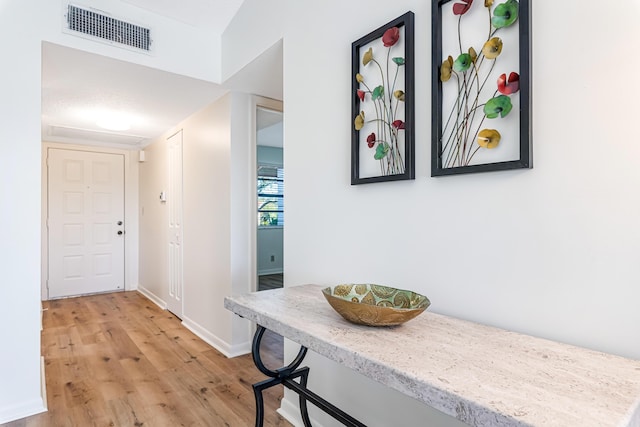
[183,95,231,347]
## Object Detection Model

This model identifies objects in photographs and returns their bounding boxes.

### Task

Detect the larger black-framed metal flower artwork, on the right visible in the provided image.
[431,0,531,176]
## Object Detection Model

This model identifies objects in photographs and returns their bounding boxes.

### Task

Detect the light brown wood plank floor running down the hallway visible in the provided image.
[4,292,291,427]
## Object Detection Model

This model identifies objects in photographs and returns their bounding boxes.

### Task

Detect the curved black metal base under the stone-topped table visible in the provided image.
[251,325,366,427]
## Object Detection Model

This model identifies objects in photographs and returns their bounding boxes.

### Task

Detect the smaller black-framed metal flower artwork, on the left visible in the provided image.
[351,12,415,185]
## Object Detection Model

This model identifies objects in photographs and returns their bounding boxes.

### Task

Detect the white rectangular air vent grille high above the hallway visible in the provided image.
[66,5,151,52]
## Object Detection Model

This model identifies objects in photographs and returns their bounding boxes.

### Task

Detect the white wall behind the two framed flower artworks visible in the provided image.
[223,0,640,426]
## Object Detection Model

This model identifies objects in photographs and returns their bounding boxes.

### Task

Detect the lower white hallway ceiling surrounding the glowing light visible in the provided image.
[42,43,225,145]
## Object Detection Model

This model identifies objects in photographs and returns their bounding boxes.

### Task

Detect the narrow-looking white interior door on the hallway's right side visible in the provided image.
[166,131,183,318]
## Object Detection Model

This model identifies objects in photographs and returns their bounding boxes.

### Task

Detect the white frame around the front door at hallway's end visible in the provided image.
[40,142,139,301]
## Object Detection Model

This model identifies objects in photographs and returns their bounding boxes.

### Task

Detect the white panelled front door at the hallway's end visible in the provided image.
[47,148,125,298]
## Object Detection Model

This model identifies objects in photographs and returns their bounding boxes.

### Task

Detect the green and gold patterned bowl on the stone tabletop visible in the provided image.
[322,283,431,326]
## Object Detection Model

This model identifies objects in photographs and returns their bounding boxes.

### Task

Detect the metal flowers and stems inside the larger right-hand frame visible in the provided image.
[439,0,520,168]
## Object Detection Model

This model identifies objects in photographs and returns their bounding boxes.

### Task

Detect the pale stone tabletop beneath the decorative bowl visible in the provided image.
[225,285,640,427]
